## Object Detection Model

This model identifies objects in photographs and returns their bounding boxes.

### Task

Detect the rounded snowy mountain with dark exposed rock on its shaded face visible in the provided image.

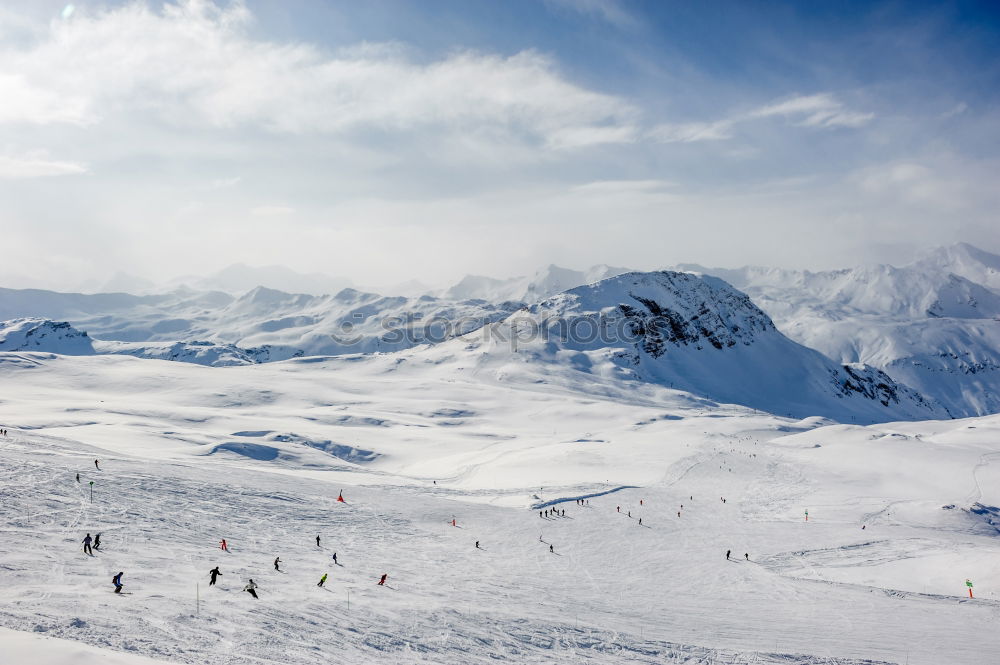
[452,271,950,421]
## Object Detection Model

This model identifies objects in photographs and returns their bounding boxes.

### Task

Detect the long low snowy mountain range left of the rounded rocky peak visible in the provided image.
[0,287,522,360]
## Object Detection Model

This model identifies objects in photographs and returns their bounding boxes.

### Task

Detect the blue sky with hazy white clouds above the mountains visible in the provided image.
[0,0,1000,290]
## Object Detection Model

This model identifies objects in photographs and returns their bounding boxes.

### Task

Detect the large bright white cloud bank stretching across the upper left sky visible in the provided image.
[0,0,635,148]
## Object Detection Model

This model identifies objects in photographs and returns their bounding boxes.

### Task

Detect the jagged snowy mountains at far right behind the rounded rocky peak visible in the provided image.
[681,244,1000,416]
